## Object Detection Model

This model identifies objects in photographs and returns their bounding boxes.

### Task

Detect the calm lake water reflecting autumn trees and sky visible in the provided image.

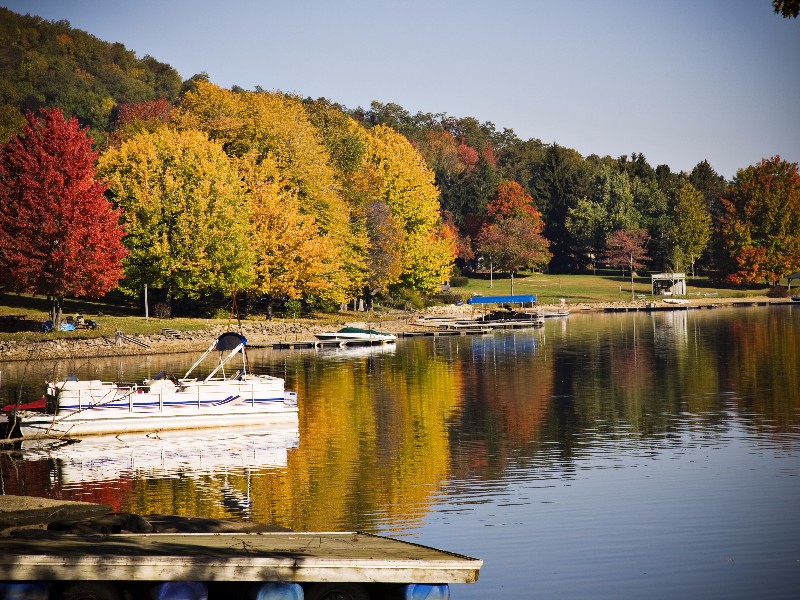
[0,306,800,600]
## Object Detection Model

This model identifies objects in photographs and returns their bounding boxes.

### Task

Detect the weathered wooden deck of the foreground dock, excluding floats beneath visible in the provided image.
[0,532,483,583]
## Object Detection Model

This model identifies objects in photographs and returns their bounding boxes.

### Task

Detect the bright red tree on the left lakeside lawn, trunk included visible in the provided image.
[0,109,126,327]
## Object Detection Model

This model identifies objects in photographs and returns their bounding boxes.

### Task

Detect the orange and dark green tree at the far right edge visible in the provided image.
[721,156,800,285]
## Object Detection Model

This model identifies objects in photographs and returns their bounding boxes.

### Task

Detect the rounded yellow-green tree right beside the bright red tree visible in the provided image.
[99,127,253,302]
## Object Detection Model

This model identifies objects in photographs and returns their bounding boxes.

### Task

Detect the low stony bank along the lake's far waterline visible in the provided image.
[0,296,792,364]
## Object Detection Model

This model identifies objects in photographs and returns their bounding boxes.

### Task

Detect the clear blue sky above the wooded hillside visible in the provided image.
[0,0,800,178]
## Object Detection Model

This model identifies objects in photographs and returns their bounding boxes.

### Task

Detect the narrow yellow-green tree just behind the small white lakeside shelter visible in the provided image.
[667,182,712,275]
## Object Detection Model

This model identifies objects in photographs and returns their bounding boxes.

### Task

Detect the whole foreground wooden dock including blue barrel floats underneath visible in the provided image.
[0,496,483,600]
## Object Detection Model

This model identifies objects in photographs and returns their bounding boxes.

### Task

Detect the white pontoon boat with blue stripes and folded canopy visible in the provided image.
[4,332,297,438]
